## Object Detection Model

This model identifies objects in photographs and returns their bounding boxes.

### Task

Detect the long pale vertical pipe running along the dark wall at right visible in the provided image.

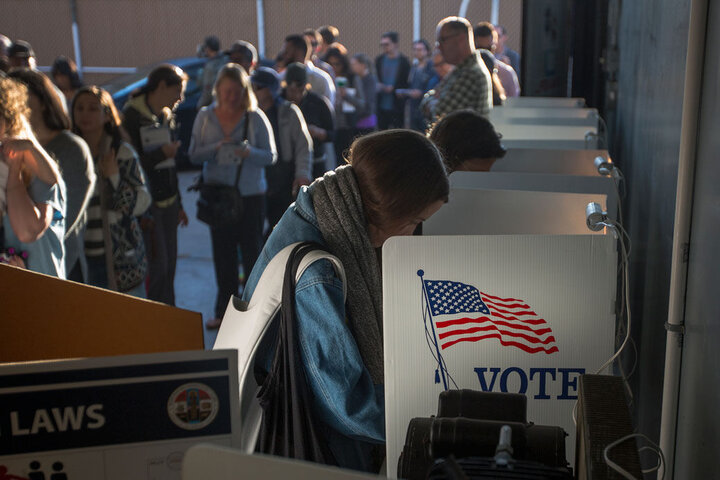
[658,0,709,480]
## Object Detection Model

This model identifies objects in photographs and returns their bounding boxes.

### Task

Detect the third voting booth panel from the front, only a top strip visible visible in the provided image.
[450,172,618,219]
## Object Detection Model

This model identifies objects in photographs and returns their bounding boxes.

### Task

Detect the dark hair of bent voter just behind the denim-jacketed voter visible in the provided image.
[428,110,505,172]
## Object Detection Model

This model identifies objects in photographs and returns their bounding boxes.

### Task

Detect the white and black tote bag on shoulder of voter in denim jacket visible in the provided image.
[213,243,347,463]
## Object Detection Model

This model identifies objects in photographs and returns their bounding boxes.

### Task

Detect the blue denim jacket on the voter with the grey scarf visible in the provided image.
[243,187,385,471]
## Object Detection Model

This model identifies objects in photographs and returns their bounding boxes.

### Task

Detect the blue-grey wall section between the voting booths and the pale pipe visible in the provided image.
[608,0,690,462]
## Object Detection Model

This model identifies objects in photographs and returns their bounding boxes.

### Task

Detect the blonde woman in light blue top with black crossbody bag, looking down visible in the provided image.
[188,63,277,328]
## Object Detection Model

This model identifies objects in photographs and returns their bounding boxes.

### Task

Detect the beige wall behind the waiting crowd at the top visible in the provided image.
[0,0,522,86]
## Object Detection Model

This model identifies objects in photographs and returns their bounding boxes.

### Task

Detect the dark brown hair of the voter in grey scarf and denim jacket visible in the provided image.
[347,130,450,228]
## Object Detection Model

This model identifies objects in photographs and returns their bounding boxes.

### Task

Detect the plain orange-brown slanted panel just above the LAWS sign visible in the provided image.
[0,265,203,362]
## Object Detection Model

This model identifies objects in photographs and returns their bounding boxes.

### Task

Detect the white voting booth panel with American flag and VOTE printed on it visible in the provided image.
[382,235,617,476]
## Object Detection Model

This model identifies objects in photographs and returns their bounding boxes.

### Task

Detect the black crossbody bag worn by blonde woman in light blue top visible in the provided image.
[195,112,250,228]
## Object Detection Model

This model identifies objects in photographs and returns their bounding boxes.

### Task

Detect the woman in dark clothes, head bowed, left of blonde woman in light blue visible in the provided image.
[123,64,188,306]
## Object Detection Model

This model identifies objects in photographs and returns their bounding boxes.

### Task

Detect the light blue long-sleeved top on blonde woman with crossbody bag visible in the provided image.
[188,103,277,197]
